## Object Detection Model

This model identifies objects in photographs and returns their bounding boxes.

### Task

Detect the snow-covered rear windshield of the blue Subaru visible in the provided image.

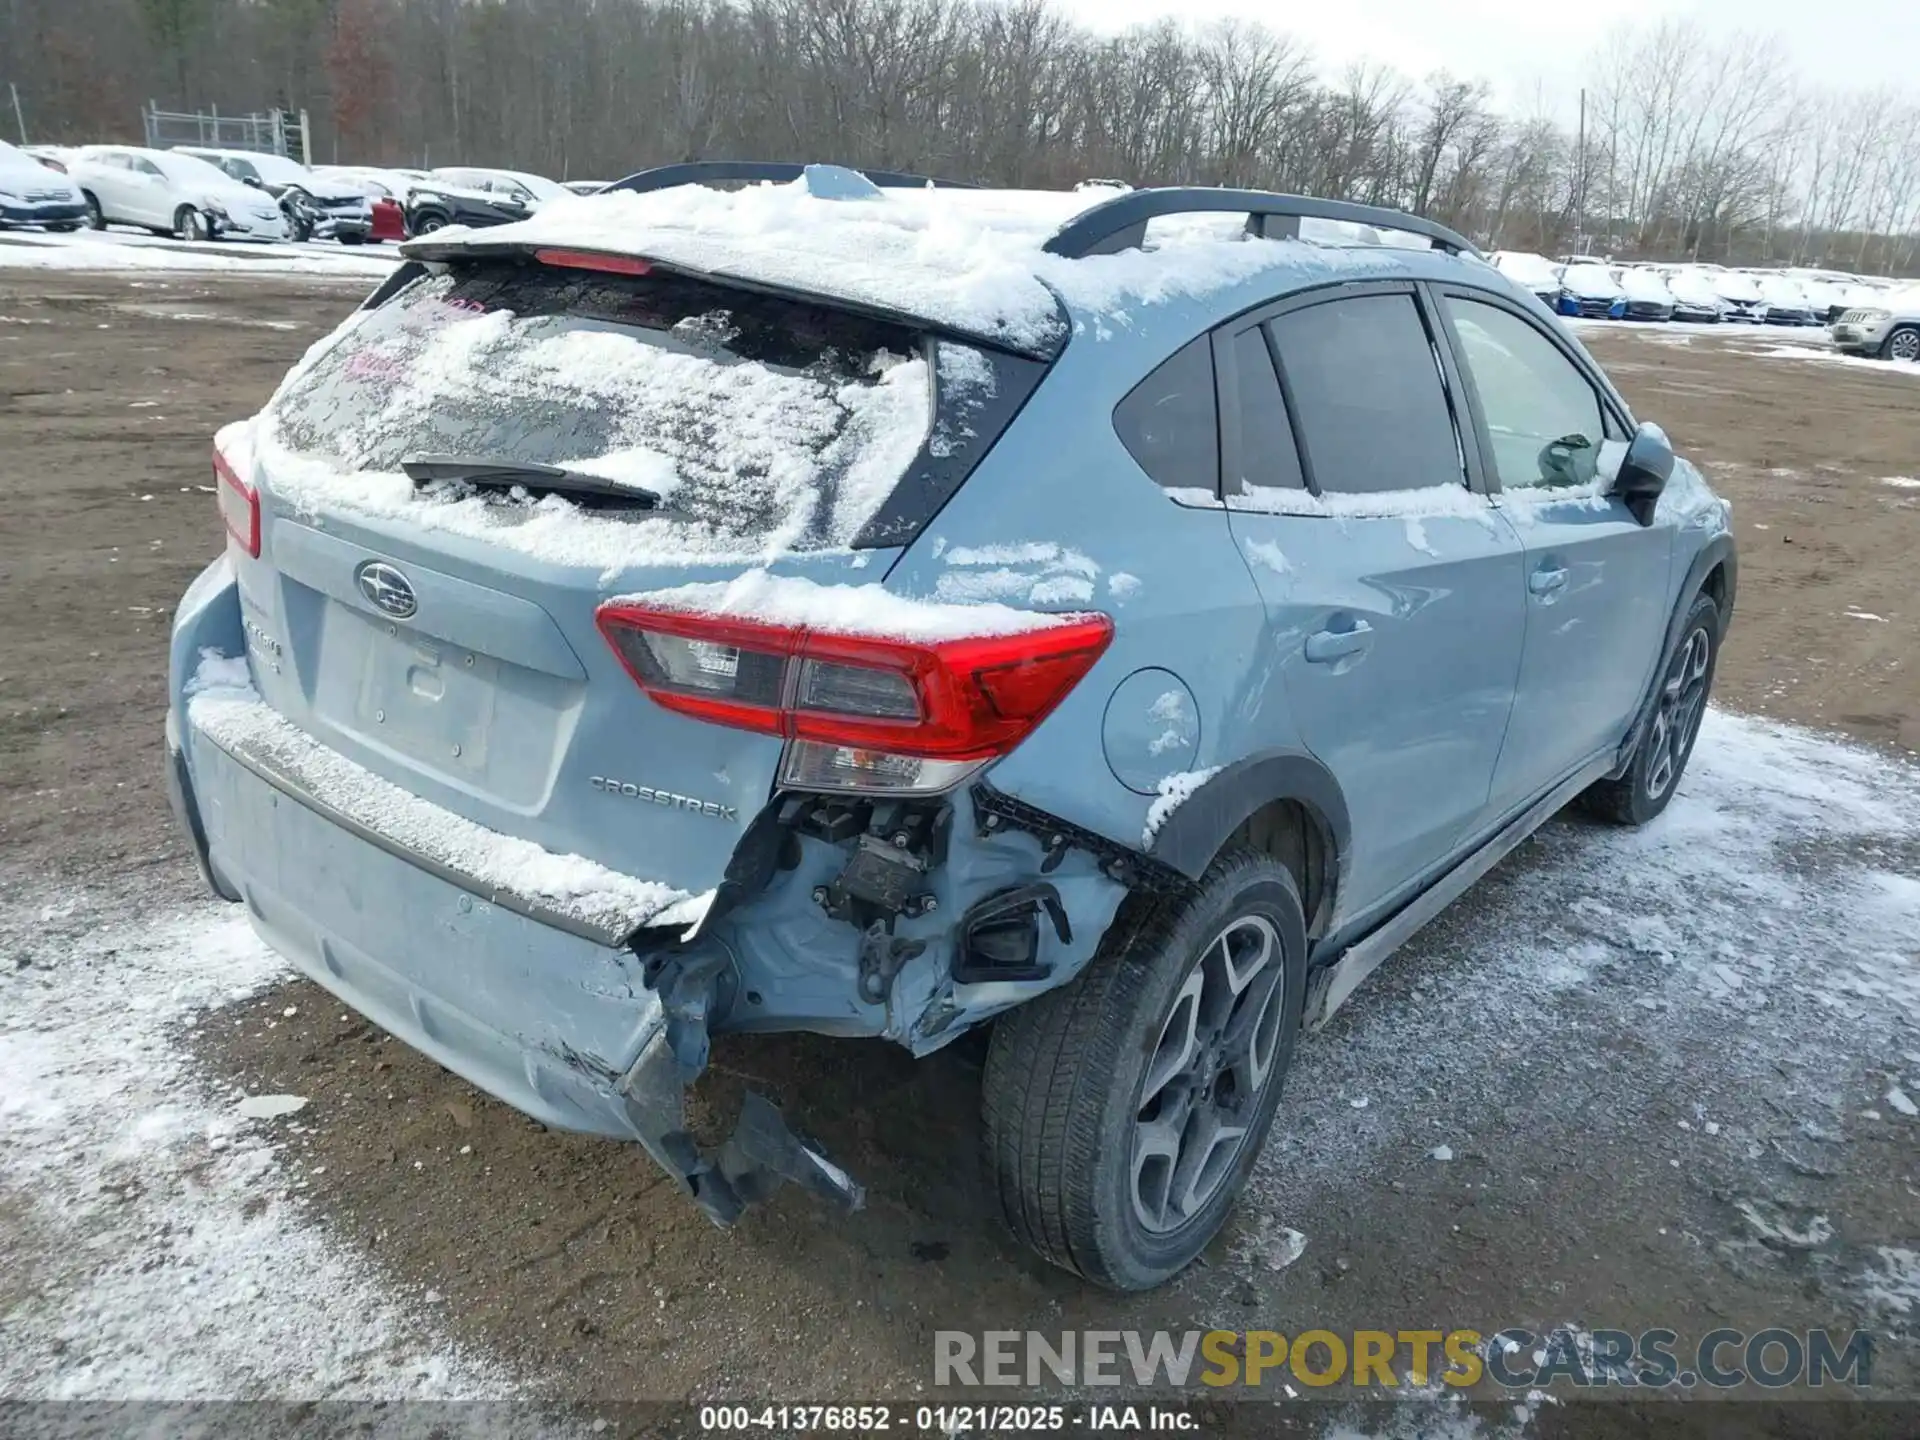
[269,259,933,549]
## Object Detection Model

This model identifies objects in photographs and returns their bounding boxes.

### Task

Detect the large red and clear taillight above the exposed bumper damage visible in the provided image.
[599,605,1114,760]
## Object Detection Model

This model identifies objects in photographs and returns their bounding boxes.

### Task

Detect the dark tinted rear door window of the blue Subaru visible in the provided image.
[1271,296,1465,493]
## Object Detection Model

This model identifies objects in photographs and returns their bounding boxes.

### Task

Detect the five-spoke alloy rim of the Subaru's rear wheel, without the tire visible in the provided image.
[1129,916,1286,1235]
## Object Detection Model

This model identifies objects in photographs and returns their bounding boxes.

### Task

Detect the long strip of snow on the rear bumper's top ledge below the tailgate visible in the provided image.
[186,655,705,935]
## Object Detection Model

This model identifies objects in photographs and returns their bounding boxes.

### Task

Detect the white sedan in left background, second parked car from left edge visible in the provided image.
[67,146,288,240]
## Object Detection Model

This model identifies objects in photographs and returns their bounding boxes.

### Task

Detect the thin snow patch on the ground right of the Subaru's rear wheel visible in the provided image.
[1228,710,1920,1413]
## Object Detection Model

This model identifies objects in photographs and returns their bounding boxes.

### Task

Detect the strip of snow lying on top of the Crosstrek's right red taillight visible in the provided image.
[609,570,1071,641]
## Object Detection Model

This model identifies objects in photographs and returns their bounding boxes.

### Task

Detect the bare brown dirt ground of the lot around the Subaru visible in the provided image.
[0,275,1920,1434]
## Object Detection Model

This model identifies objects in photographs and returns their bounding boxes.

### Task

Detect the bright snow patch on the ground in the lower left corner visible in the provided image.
[0,887,515,1400]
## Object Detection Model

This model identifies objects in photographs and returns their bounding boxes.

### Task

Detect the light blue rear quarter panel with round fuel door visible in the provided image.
[887,307,1288,847]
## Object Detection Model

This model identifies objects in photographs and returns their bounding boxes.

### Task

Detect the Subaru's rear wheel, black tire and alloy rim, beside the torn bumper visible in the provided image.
[981,851,1306,1290]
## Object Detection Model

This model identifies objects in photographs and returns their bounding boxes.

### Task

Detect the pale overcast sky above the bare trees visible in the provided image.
[1064,0,1920,117]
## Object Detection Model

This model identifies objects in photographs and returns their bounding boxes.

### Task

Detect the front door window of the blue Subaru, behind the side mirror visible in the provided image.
[1446,296,1609,490]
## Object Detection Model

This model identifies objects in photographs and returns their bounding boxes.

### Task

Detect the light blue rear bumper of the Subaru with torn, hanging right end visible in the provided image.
[169,683,864,1225]
